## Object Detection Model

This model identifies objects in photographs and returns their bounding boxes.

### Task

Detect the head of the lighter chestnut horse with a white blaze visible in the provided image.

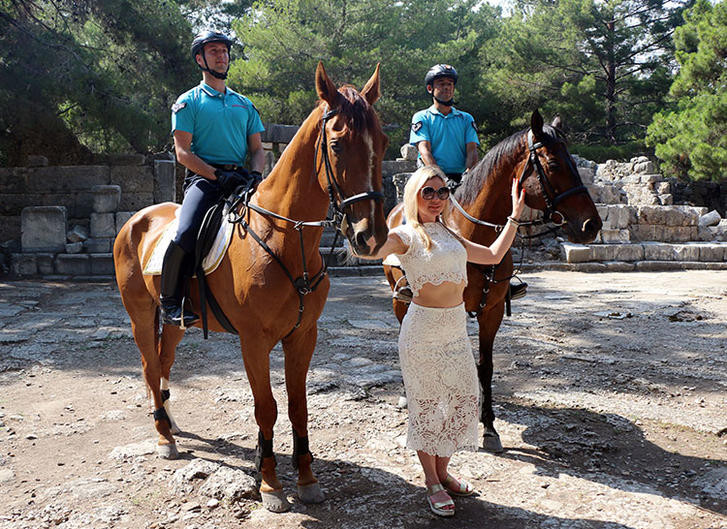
[316,63,389,255]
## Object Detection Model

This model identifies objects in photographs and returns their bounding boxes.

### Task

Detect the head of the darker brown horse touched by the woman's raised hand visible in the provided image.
[520,110,603,243]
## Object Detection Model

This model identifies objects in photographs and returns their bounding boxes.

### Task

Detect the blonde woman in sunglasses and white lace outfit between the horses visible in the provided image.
[357,167,525,516]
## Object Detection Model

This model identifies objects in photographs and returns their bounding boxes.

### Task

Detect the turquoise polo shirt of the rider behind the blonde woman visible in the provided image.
[409,105,480,174]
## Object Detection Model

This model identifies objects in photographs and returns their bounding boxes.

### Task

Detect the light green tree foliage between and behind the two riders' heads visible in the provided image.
[230,0,497,155]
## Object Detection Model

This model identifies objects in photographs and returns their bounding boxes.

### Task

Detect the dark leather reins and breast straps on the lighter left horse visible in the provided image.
[227,109,384,338]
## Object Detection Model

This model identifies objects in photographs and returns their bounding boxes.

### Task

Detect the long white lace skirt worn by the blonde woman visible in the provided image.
[399,303,480,457]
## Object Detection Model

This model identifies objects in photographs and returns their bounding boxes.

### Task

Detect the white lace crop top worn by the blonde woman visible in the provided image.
[390,222,467,296]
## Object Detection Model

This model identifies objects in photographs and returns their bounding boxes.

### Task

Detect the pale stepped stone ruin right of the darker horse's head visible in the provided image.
[562,155,727,268]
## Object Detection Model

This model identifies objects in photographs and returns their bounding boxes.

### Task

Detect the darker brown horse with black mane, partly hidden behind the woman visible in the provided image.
[384,110,602,452]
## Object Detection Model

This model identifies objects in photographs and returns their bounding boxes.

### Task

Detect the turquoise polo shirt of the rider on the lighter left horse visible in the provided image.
[172,81,265,165]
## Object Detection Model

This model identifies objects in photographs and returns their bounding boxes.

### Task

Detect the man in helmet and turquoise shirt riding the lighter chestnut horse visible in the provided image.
[160,31,265,327]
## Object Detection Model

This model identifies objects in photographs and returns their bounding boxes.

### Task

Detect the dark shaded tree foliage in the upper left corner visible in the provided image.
[0,0,194,163]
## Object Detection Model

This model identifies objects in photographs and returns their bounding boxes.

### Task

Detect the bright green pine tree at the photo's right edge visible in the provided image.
[647,0,727,180]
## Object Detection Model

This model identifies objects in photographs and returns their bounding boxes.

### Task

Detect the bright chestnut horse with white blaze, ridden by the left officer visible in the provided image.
[114,63,388,512]
